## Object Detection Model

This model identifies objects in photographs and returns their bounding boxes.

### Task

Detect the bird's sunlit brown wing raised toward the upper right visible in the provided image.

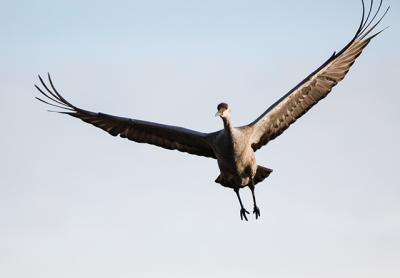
[246,0,389,150]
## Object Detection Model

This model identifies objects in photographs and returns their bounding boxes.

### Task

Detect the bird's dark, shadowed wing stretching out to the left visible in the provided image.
[35,75,219,158]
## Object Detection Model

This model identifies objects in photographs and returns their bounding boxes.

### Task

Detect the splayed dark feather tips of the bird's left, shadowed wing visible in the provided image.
[35,73,78,114]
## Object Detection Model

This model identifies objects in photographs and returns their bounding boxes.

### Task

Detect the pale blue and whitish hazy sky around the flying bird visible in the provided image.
[0,0,400,278]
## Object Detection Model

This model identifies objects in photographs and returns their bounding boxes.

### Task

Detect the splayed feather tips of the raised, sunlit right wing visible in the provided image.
[354,0,390,40]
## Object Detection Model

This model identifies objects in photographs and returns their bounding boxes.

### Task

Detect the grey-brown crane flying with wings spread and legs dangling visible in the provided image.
[35,0,389,221]
